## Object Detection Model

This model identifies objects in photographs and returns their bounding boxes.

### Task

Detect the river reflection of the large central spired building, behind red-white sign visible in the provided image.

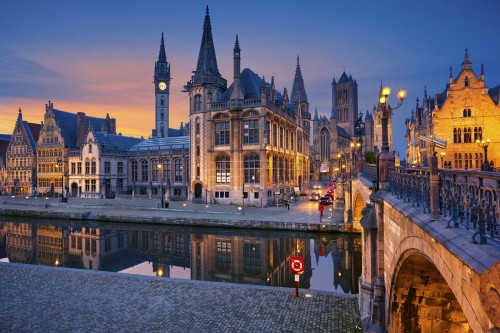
[191,235,312,288]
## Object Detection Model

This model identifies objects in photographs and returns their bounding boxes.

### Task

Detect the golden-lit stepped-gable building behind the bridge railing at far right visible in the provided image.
[406,49,500,170]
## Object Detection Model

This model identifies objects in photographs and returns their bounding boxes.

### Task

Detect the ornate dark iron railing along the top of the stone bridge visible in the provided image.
[389,167,500,244]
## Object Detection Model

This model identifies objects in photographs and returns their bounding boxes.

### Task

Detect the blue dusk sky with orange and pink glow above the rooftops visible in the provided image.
[0,0,500,156]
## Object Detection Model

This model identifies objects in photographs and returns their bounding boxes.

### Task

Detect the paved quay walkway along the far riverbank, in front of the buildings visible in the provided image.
[0,196,345,231]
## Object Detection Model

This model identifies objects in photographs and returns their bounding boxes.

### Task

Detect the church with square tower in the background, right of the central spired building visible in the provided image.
[312,72,373,180]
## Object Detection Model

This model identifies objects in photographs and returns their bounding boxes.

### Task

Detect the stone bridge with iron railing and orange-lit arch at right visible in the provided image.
[352,163,500,332]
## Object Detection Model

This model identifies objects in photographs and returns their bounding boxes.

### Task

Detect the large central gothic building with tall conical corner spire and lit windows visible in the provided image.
[185,7,311,206]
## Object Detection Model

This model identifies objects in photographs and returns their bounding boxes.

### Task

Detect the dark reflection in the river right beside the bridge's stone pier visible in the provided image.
[314,234,362,294]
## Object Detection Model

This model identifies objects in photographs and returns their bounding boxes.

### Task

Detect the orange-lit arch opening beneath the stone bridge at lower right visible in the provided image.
[385,236,487,332]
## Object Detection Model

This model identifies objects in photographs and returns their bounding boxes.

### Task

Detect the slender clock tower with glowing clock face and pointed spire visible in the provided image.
[153,33,170,138]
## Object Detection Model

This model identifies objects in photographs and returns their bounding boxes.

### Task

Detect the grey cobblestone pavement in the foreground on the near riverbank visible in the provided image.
[0,263,361,333]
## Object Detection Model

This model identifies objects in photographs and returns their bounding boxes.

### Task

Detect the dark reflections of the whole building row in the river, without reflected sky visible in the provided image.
[0,222,330,291]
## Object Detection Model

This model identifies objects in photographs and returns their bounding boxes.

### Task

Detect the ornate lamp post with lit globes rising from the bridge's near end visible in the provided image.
[378,87,406,189]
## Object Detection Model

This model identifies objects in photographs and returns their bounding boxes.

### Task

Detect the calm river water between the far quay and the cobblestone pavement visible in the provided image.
[0,217,361,294]
